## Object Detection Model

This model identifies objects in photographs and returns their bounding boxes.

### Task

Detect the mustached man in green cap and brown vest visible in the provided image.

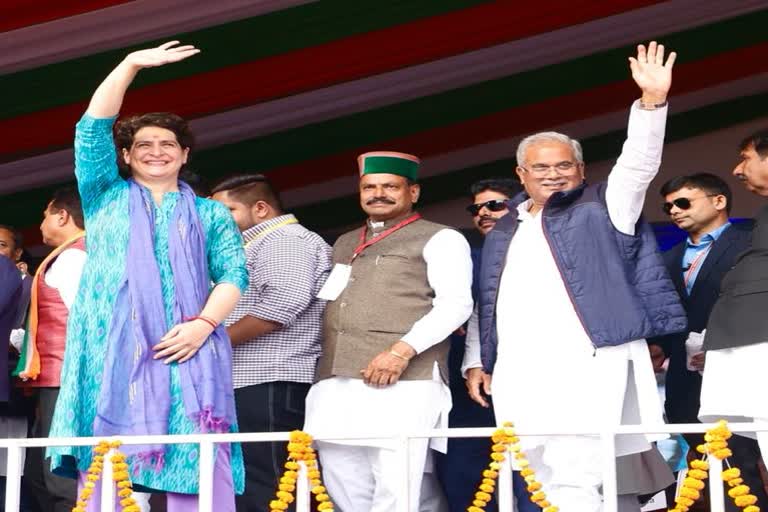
[305,151,472,512]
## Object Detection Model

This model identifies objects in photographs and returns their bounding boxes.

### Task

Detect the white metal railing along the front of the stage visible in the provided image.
[0,423,768,512]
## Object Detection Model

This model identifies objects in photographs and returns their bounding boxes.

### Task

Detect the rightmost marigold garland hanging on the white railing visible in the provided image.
[670,420,760,512]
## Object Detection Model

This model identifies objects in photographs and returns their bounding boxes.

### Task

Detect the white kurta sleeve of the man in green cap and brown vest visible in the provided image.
[403,229,472,354]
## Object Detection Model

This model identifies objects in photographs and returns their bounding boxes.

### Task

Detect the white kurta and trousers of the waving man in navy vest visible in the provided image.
[463,105,666,512]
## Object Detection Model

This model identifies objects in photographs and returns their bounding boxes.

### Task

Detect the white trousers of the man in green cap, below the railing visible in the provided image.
[317,439,429,512]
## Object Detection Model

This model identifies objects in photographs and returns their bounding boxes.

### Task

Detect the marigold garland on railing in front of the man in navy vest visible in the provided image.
[467,422,559,512]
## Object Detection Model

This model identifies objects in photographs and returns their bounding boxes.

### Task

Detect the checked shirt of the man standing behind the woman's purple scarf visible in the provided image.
[225,214,331,388]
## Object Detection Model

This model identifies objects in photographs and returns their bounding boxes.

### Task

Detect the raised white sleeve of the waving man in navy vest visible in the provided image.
[605,101,667,235]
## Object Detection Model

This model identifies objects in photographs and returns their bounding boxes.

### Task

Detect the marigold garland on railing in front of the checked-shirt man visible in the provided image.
[269,430,333,512]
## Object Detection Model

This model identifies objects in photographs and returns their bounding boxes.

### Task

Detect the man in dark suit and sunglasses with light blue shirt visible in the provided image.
[649,173,766,510]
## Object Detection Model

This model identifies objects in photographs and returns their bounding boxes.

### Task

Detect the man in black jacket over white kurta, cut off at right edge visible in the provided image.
[699,130,768,494]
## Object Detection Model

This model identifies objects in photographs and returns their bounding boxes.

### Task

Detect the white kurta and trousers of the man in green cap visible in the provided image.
[304,229,472,512]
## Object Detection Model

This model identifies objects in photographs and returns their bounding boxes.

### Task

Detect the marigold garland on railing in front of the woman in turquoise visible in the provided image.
[72,441,141,512]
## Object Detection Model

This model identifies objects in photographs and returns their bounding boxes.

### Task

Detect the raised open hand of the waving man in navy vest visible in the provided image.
[629,41,677,103]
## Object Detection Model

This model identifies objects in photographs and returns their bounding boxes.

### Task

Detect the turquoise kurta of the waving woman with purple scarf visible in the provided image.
[48,114,248,494]
